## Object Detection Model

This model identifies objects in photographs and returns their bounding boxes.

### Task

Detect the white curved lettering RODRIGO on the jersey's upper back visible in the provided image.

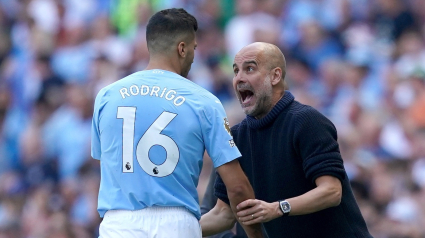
[120,85,186,106]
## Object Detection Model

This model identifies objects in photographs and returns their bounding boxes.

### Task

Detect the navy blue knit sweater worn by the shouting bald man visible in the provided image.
[215,91,372,238]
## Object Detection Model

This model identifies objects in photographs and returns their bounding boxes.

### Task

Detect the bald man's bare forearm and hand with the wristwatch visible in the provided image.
[237,175,342,225]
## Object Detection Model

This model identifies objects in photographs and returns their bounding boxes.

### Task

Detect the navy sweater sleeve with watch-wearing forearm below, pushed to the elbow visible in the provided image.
[294,107,345,183]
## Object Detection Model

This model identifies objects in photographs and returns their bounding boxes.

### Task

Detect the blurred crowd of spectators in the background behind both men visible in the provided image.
[0,0,425,238]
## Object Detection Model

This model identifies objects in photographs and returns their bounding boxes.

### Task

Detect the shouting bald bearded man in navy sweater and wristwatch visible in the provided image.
[201,43,372,238]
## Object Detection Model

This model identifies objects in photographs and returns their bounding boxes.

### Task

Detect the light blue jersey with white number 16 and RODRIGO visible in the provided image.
[91,70,241,219]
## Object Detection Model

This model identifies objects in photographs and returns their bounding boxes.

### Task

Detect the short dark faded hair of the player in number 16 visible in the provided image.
[146,8,198,53]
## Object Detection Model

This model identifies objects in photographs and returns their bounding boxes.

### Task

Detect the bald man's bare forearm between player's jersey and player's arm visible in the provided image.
[200,199,236,236]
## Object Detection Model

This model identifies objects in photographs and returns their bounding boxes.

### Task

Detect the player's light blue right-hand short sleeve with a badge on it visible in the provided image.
[201,99,241,168]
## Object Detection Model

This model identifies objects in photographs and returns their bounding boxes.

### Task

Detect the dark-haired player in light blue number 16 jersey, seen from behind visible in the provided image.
[92,9,262,238]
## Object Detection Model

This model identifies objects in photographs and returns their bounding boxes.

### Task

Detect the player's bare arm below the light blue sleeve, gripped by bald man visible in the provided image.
[217,160,263,238]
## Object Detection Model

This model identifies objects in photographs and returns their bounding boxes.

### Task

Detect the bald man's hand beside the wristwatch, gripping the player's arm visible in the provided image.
[236,199,282,226]
